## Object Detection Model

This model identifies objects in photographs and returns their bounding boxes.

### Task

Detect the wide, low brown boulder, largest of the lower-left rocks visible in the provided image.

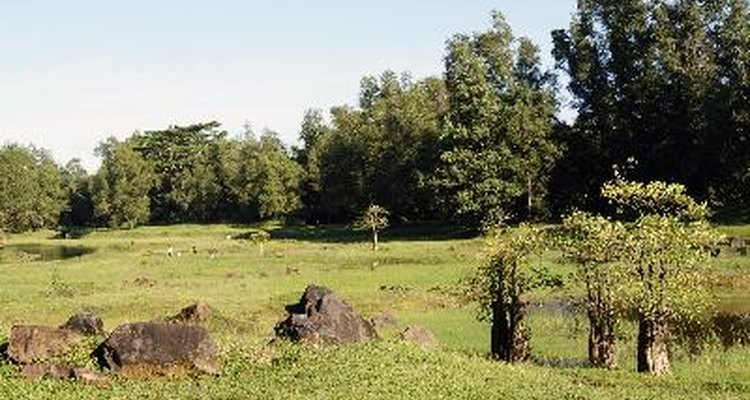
[91,322,219,376]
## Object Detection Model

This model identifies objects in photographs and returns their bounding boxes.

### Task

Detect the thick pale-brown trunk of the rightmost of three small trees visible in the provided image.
[637,316,669,375]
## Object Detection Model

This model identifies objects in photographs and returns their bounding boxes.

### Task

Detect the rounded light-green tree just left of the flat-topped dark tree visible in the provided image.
[92,138,155,228]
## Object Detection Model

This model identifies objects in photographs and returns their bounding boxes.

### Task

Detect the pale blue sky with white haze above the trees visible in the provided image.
[0,0,576,172]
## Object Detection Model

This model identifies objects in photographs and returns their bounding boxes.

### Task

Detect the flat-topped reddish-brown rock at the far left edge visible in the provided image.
[7,325,80,364]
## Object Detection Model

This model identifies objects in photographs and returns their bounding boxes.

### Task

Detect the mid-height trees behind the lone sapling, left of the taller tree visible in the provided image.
[303,71,448,222]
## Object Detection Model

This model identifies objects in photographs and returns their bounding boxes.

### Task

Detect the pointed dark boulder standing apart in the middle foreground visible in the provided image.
[274,285,376,343]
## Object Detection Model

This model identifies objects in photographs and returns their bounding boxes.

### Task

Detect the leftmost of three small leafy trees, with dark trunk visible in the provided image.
[468,224,545,362]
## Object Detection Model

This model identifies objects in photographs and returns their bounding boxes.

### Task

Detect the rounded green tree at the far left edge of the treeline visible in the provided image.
[0,144,65,232]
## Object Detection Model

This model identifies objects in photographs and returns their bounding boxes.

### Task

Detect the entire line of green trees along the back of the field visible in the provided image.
[0,0,750,231]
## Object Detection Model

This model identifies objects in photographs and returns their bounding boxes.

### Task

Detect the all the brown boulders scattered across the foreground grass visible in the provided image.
[4,285,437,384]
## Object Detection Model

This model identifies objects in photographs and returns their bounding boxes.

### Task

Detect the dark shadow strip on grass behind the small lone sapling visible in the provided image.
[256,224,474,243]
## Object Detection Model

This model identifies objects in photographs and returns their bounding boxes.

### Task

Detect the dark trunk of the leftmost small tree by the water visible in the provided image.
[490,301,529,362]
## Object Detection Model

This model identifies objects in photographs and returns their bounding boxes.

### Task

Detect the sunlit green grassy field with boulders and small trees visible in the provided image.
[0,225,750,399]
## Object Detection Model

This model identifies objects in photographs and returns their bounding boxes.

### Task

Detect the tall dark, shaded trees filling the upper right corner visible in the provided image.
[553,0,750,216]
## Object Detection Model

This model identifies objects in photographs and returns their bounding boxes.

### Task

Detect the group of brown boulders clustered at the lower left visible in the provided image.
[4,303,219,383]
